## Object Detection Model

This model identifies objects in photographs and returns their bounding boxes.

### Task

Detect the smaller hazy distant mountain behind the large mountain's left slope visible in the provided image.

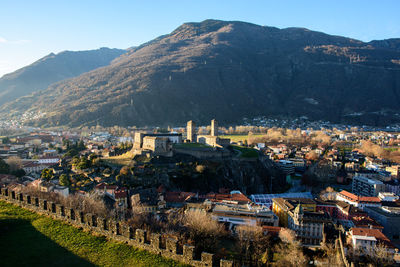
[0,48,126,105]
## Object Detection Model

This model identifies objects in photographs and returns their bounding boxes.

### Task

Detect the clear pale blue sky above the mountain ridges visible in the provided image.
[0,0,400,77]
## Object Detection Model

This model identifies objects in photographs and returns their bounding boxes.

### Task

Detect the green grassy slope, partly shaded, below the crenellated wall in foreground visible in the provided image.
[0,201,184,266]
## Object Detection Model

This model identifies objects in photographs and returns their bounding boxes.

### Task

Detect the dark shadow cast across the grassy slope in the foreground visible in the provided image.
[0,219,95,267]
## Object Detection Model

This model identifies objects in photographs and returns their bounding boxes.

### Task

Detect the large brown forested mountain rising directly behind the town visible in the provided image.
[0,20,400,126]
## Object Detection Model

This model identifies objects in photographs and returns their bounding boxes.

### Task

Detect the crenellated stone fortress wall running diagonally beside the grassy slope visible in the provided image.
[0,188,233,267]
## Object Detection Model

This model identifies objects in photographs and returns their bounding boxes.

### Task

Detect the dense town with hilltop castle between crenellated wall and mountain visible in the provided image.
[0,120,400,266]
